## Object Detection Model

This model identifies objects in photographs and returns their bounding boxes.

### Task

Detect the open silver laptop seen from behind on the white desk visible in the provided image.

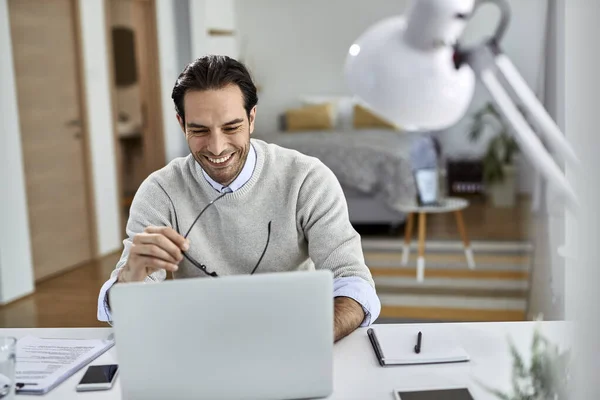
[109,270,334,400]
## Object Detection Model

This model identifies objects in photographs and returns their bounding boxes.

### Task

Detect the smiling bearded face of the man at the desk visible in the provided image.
[177,85,256,186]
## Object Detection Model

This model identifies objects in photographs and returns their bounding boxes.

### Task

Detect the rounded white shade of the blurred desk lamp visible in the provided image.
[344,0,476,131]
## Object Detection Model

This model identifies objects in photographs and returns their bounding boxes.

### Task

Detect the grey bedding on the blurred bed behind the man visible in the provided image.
[253,129,416,211]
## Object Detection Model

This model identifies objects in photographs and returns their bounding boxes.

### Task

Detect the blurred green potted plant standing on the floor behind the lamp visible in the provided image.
[469,103,519,207]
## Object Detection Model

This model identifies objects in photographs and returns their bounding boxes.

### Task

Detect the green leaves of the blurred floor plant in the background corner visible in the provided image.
[469,103,523,185]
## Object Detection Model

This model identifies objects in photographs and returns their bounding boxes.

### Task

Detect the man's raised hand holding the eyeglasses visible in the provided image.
[117,226,190,282]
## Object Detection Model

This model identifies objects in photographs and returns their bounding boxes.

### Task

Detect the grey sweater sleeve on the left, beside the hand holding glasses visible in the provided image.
[97,175,174,323]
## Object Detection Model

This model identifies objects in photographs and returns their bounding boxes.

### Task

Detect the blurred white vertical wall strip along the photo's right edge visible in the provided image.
[564,0,600,399]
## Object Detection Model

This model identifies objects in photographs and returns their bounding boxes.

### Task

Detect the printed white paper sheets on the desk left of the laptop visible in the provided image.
[15,336,115,394]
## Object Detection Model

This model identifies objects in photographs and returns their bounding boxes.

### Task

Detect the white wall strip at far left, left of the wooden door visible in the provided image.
[0,0,34,304]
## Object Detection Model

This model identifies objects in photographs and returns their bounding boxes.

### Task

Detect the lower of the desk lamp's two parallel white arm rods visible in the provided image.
[478,68,579,212]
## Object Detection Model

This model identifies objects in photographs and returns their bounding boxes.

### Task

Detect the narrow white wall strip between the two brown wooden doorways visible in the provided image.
[79,0,121,255]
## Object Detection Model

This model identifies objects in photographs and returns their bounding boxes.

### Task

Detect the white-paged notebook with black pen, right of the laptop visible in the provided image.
[368,324,469,366]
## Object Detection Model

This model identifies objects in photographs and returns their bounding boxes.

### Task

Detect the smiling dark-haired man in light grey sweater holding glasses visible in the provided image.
[98,56,381,342]
